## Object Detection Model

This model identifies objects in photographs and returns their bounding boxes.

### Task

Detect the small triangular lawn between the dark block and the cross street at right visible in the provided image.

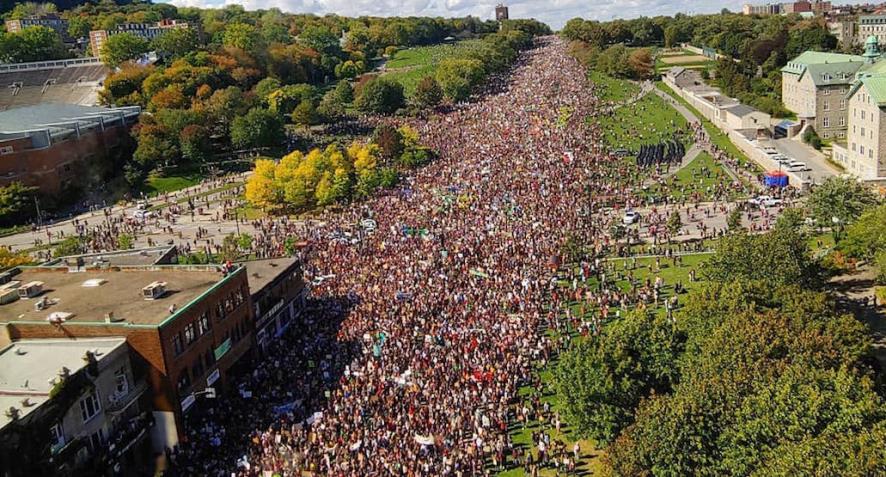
[646,151,744,201]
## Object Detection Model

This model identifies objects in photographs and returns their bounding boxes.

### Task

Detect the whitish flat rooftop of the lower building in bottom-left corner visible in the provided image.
[0,338,126,429]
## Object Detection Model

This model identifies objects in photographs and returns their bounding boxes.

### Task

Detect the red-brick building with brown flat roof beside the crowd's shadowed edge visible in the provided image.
[0,265,254,450]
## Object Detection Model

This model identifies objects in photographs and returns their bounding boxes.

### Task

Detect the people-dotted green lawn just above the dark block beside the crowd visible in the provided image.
[599,94,688,152]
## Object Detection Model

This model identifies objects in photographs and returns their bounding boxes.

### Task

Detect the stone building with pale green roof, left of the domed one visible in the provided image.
[781,51,865,139]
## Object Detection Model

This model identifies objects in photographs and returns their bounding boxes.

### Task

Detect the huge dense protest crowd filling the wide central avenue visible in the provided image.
[163,38,635,476]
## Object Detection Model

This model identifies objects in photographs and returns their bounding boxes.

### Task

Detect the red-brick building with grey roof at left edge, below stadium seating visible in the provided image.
[0,104,141,195]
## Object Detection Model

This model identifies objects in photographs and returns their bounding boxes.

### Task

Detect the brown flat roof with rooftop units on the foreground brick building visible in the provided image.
[0,266,232,325]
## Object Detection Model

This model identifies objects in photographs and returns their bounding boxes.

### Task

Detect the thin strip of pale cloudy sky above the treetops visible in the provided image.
[161,0,867,30]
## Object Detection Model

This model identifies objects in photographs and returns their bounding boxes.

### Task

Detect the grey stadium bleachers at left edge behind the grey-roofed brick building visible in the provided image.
[0,58,110,111]
